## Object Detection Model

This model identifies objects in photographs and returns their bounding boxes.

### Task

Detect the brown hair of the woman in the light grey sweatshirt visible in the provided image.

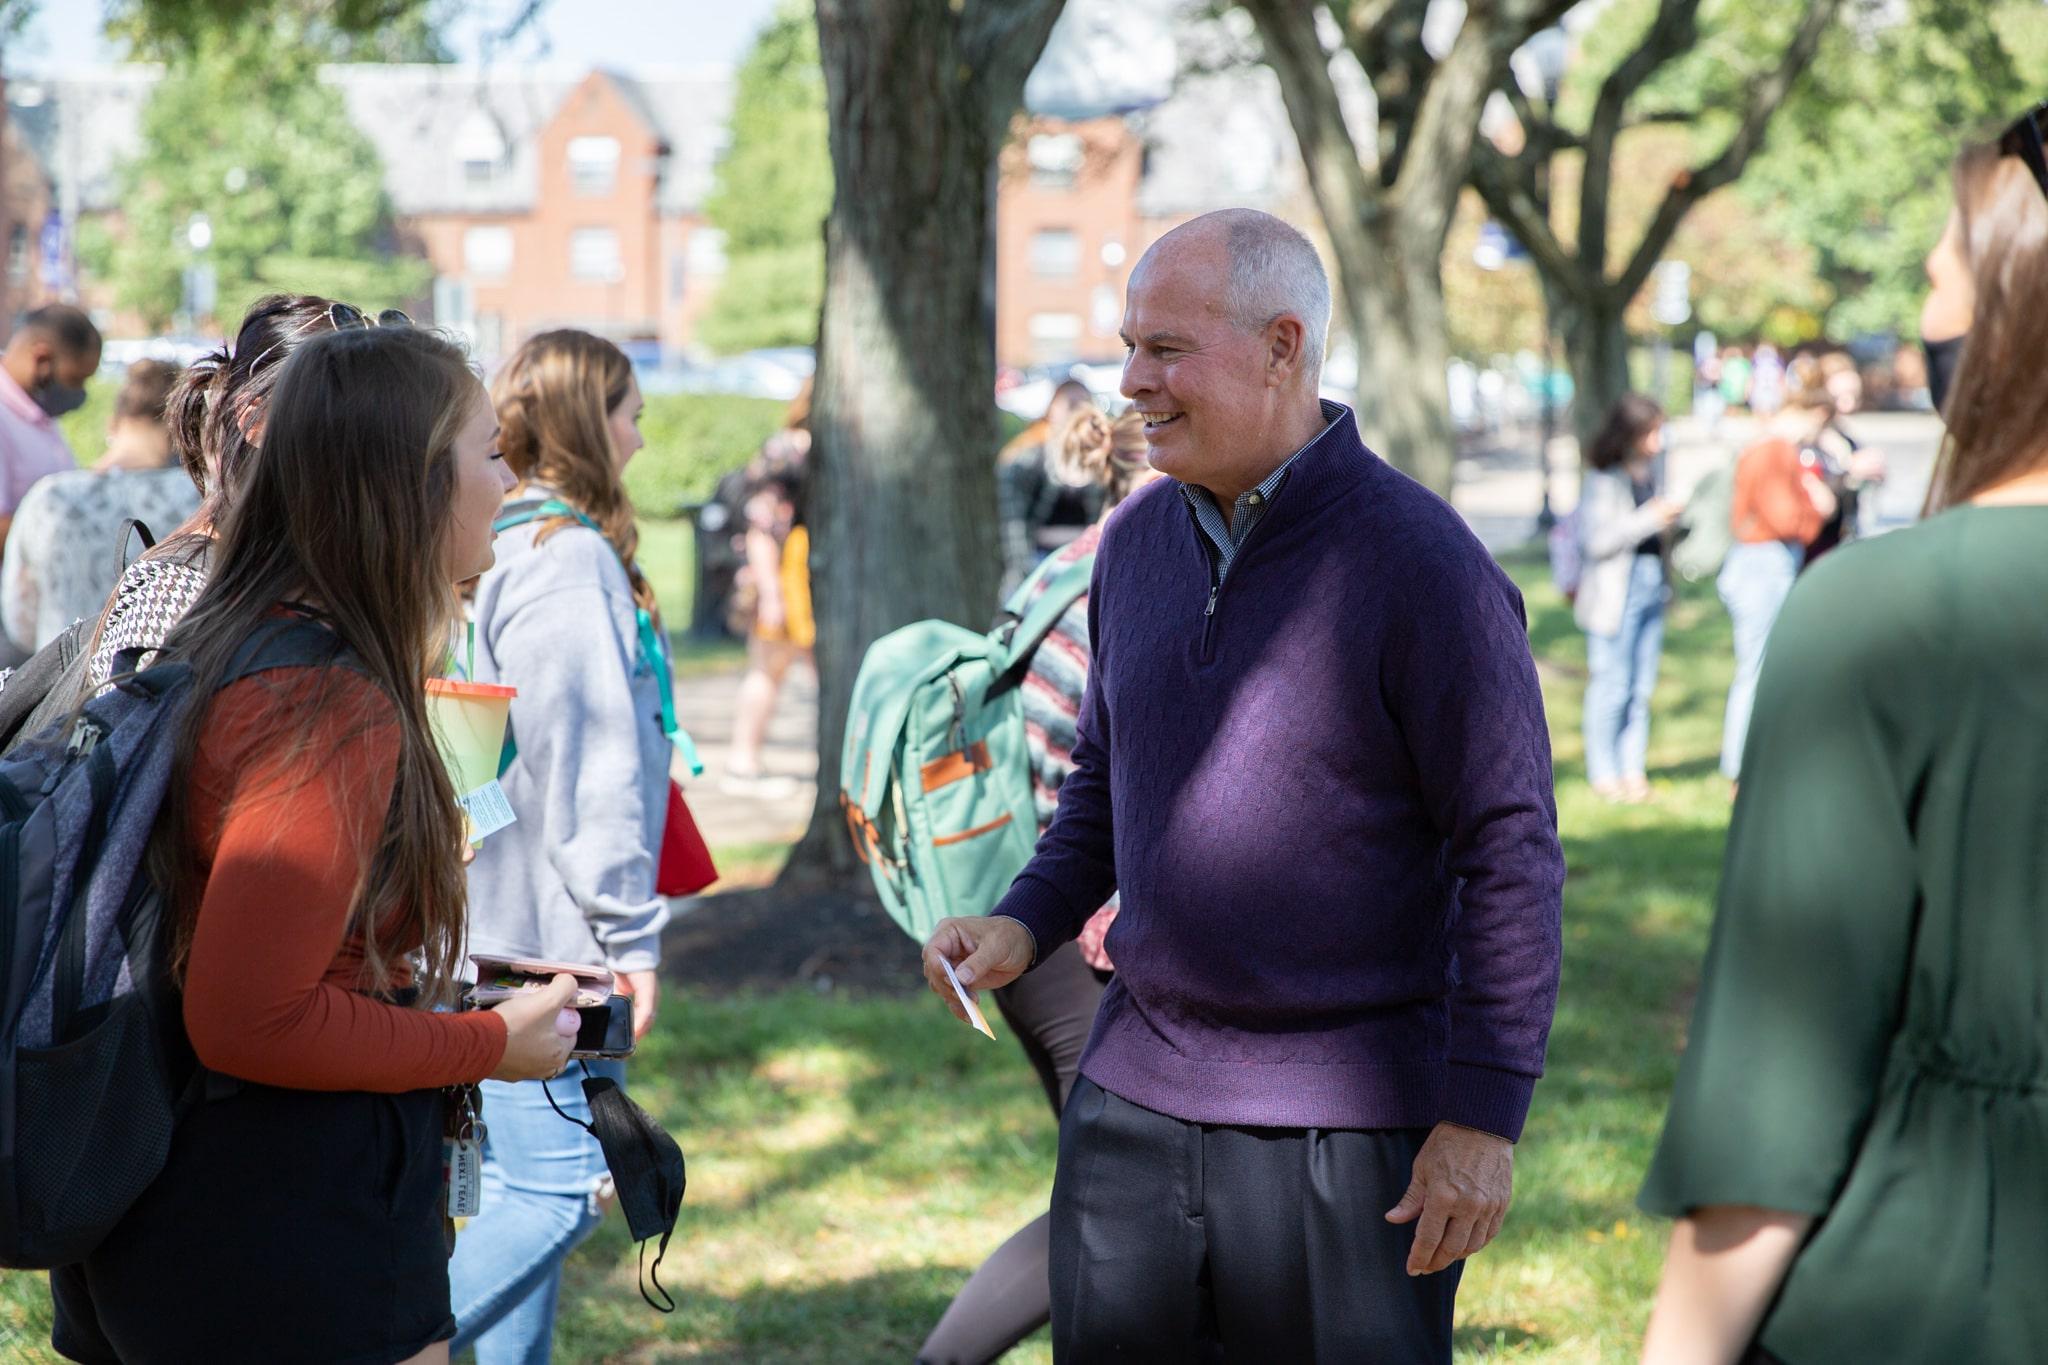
[492,327,659,612]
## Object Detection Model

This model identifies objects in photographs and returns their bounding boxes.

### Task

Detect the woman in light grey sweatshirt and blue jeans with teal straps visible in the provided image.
[451,332,674,1365]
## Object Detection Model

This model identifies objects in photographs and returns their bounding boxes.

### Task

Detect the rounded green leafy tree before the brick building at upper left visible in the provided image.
[80,23,432,327]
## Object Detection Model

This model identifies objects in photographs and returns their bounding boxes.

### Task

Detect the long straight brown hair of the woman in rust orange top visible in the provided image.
[152,327,485,1003]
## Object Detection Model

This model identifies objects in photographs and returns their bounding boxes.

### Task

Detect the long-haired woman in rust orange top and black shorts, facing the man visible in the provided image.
[51,327,573,1365]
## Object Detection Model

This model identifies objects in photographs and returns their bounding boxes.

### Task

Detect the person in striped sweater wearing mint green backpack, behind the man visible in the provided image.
[918,407,1159,1365]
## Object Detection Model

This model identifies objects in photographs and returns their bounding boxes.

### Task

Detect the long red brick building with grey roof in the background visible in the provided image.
[0,63,1311,366]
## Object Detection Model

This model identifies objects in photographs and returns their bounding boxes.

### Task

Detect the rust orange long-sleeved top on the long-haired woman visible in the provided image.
[184,669,506,1093]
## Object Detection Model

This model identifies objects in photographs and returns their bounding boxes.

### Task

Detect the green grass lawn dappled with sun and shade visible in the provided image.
[0,553,1731,1363]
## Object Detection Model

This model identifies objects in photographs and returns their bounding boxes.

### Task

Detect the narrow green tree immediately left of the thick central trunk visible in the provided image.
[702,0,831,354]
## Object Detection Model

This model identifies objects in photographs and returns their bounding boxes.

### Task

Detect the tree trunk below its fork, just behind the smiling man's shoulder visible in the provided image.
[1337,219,1458,497]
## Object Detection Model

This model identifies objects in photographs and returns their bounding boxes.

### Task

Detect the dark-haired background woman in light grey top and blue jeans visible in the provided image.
[1573,393,1683,802]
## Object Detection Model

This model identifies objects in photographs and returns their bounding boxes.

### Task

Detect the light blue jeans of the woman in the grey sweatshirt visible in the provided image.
[449,1060,627,1365]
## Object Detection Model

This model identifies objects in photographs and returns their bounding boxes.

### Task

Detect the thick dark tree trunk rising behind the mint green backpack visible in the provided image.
[784,0,1059,882]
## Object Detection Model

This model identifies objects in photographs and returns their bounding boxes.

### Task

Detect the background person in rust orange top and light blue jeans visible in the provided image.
[1714,364,1839,782]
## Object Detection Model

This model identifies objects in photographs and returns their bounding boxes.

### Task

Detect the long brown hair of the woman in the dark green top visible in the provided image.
[1927,143,2048,512]
